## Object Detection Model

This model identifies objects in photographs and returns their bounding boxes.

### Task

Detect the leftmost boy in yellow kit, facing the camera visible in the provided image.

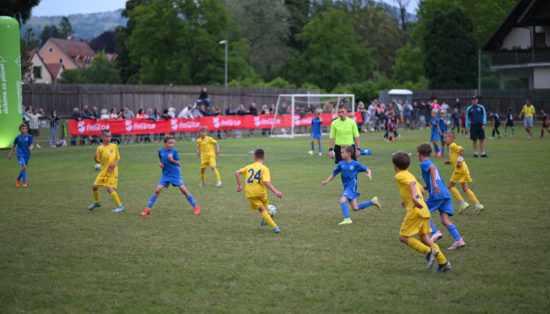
[88,129,124,213]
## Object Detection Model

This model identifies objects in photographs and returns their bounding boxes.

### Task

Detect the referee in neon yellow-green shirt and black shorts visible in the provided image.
[328,105,361,164]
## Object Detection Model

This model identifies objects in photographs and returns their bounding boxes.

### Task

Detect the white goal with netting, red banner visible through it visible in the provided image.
[271,94,355,137]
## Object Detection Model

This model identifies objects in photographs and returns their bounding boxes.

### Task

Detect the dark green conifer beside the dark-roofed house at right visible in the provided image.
[423,5,477,89]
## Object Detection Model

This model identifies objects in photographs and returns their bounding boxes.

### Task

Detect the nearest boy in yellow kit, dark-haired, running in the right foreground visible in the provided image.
[392,151,451,273]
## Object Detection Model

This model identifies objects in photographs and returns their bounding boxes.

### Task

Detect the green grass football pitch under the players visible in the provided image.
[0,131,550,313]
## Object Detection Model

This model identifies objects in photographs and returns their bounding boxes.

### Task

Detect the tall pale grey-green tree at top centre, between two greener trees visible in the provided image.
[226,0,292,80]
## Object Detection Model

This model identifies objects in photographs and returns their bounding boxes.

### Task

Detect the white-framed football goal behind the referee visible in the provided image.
[271,94,355,137]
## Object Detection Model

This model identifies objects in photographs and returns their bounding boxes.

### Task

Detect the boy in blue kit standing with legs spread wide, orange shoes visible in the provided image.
[141,135,201,216]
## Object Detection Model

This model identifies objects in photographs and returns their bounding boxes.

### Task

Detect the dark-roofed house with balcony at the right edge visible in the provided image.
[483,0,550,89]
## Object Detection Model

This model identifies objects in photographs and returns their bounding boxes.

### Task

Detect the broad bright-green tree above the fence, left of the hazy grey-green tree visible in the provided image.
[125,0,257,84]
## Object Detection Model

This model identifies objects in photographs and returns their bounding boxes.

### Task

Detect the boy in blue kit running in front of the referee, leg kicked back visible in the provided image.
[322,145,382,225]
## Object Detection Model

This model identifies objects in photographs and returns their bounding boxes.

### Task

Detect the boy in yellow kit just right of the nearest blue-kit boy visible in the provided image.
[444,131,485,215]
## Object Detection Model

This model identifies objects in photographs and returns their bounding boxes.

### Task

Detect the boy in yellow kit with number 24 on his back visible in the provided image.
[235,148,283,233]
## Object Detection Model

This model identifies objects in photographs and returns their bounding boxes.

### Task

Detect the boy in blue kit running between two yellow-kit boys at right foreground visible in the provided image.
[416,143,466,250]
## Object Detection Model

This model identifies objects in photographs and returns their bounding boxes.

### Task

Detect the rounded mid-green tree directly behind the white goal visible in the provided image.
[291,9,374,90]
